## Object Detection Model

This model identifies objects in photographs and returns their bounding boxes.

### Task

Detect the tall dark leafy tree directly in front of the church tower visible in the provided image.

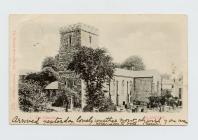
[68,47,114,111]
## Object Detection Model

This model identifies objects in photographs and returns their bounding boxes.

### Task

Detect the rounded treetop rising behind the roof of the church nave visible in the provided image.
[120,56,145,71]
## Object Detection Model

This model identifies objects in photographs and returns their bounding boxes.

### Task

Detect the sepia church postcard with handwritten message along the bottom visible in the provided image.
[9,14,188,125]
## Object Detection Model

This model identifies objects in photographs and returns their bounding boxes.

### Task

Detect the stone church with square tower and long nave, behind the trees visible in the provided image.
[46,23,161,108]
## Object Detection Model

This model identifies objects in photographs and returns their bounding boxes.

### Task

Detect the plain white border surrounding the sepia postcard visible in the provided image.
[0,0,198,140]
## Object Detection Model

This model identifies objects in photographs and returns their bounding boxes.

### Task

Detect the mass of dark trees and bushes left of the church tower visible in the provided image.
[18,55,59,112]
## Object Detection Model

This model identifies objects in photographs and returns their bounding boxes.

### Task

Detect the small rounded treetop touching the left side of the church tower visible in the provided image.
[41,56,58,71]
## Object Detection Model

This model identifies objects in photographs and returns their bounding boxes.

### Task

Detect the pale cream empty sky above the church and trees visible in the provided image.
[10,14,187,73]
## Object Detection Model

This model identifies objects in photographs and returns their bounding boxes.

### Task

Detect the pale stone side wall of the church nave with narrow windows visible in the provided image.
[104,75,161,106]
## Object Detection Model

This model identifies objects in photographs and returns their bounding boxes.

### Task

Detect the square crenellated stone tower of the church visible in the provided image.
[58,23,98,93]
